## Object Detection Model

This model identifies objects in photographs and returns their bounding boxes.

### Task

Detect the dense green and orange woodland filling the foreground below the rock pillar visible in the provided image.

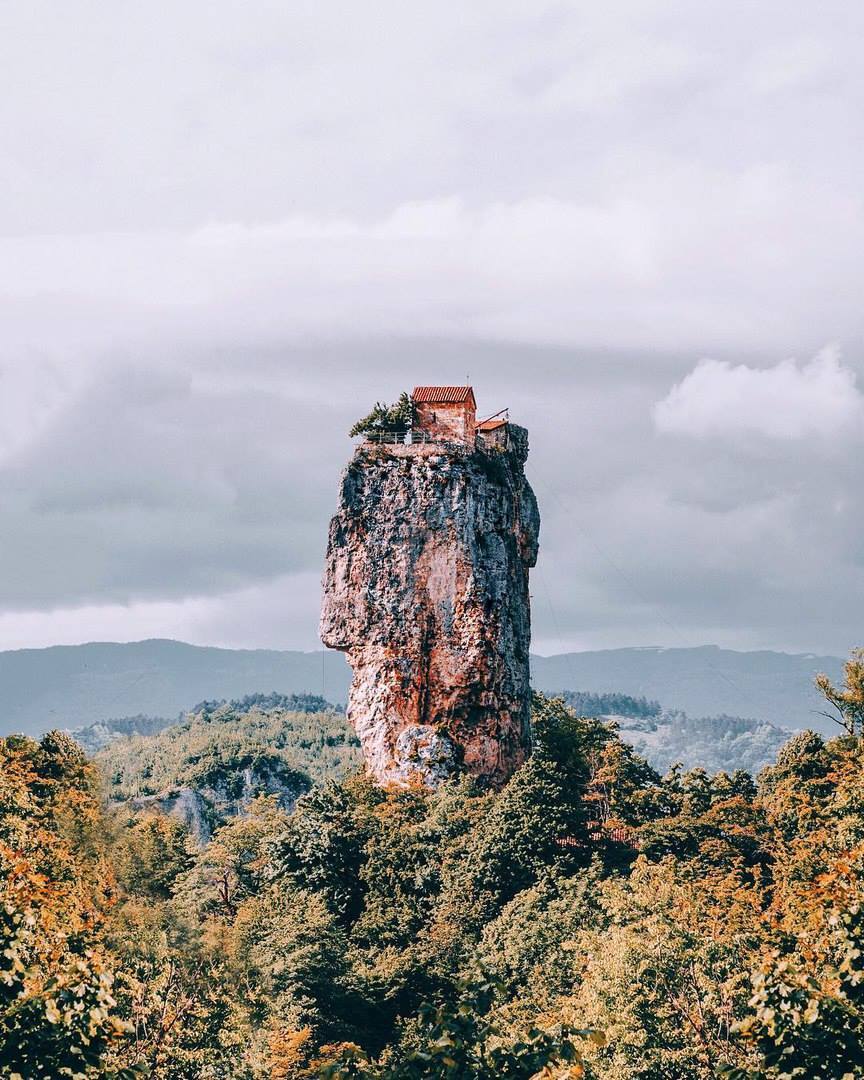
[0,653,864,1080]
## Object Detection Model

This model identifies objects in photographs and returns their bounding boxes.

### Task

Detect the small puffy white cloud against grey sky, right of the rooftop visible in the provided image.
[653,347,864,440]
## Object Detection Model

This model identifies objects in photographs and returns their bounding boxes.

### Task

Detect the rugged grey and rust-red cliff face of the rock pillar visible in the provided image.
[321,426,540,786]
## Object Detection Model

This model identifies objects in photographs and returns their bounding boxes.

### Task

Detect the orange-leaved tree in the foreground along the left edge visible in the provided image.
[0,731,133,1080]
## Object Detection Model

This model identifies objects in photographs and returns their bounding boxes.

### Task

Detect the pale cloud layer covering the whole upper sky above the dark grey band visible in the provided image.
[0,6,864,362]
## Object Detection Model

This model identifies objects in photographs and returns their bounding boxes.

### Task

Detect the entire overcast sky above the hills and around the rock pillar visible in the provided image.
[0,0,864,653]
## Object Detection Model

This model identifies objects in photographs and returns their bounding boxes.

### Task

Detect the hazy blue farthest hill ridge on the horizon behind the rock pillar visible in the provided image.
[0,639,842,734]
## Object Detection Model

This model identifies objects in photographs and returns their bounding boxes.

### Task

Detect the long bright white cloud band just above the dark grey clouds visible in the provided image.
[0,180,864,362]
